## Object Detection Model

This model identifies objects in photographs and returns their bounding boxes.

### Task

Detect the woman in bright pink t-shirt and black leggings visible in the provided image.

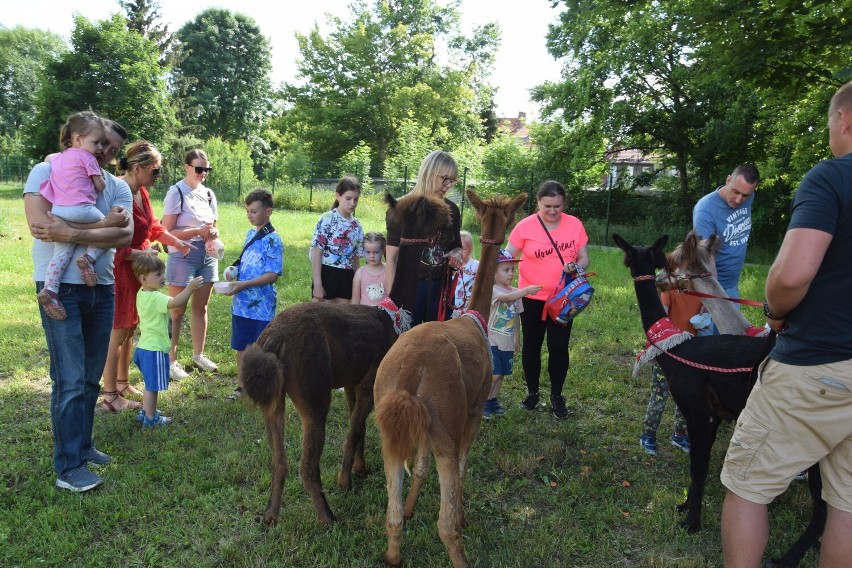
[506,181,589,420]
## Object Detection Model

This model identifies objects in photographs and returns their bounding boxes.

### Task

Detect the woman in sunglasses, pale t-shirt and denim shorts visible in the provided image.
[163,148,219,380]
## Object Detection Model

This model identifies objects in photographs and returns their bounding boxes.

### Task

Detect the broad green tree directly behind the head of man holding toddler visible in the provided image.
[28,14,175,158]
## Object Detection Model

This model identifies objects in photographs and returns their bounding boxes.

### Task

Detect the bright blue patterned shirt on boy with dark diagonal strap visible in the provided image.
[231,228,284,321]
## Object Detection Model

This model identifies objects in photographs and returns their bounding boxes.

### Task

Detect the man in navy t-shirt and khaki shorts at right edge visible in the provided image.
[721,82,852,566]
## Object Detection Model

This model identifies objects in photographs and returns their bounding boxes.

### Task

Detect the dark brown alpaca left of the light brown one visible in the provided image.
[240,196,450,524]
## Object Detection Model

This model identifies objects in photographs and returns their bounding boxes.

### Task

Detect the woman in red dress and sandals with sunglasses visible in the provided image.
[102,140,192,412]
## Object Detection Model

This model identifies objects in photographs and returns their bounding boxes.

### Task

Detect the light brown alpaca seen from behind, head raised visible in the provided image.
[373,190,527,568]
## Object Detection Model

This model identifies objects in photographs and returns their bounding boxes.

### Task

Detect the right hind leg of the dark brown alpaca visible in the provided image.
[299,398,337,525]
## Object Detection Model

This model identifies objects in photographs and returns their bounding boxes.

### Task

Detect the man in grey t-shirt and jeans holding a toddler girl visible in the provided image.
[24,123,133,492]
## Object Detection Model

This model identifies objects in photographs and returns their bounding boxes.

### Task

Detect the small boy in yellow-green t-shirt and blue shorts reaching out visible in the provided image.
[133,254,204,428]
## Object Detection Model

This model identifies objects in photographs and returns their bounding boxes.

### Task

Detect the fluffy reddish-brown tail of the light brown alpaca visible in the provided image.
[376,390,432,462]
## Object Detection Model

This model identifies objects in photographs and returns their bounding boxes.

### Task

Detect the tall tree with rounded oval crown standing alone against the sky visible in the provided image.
[174,8,272,144]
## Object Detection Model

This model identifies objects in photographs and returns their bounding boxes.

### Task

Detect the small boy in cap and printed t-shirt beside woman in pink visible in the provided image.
[482,250,541,420]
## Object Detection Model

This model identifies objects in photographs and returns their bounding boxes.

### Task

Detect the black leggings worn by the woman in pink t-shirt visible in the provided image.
[521,298,574,396]
